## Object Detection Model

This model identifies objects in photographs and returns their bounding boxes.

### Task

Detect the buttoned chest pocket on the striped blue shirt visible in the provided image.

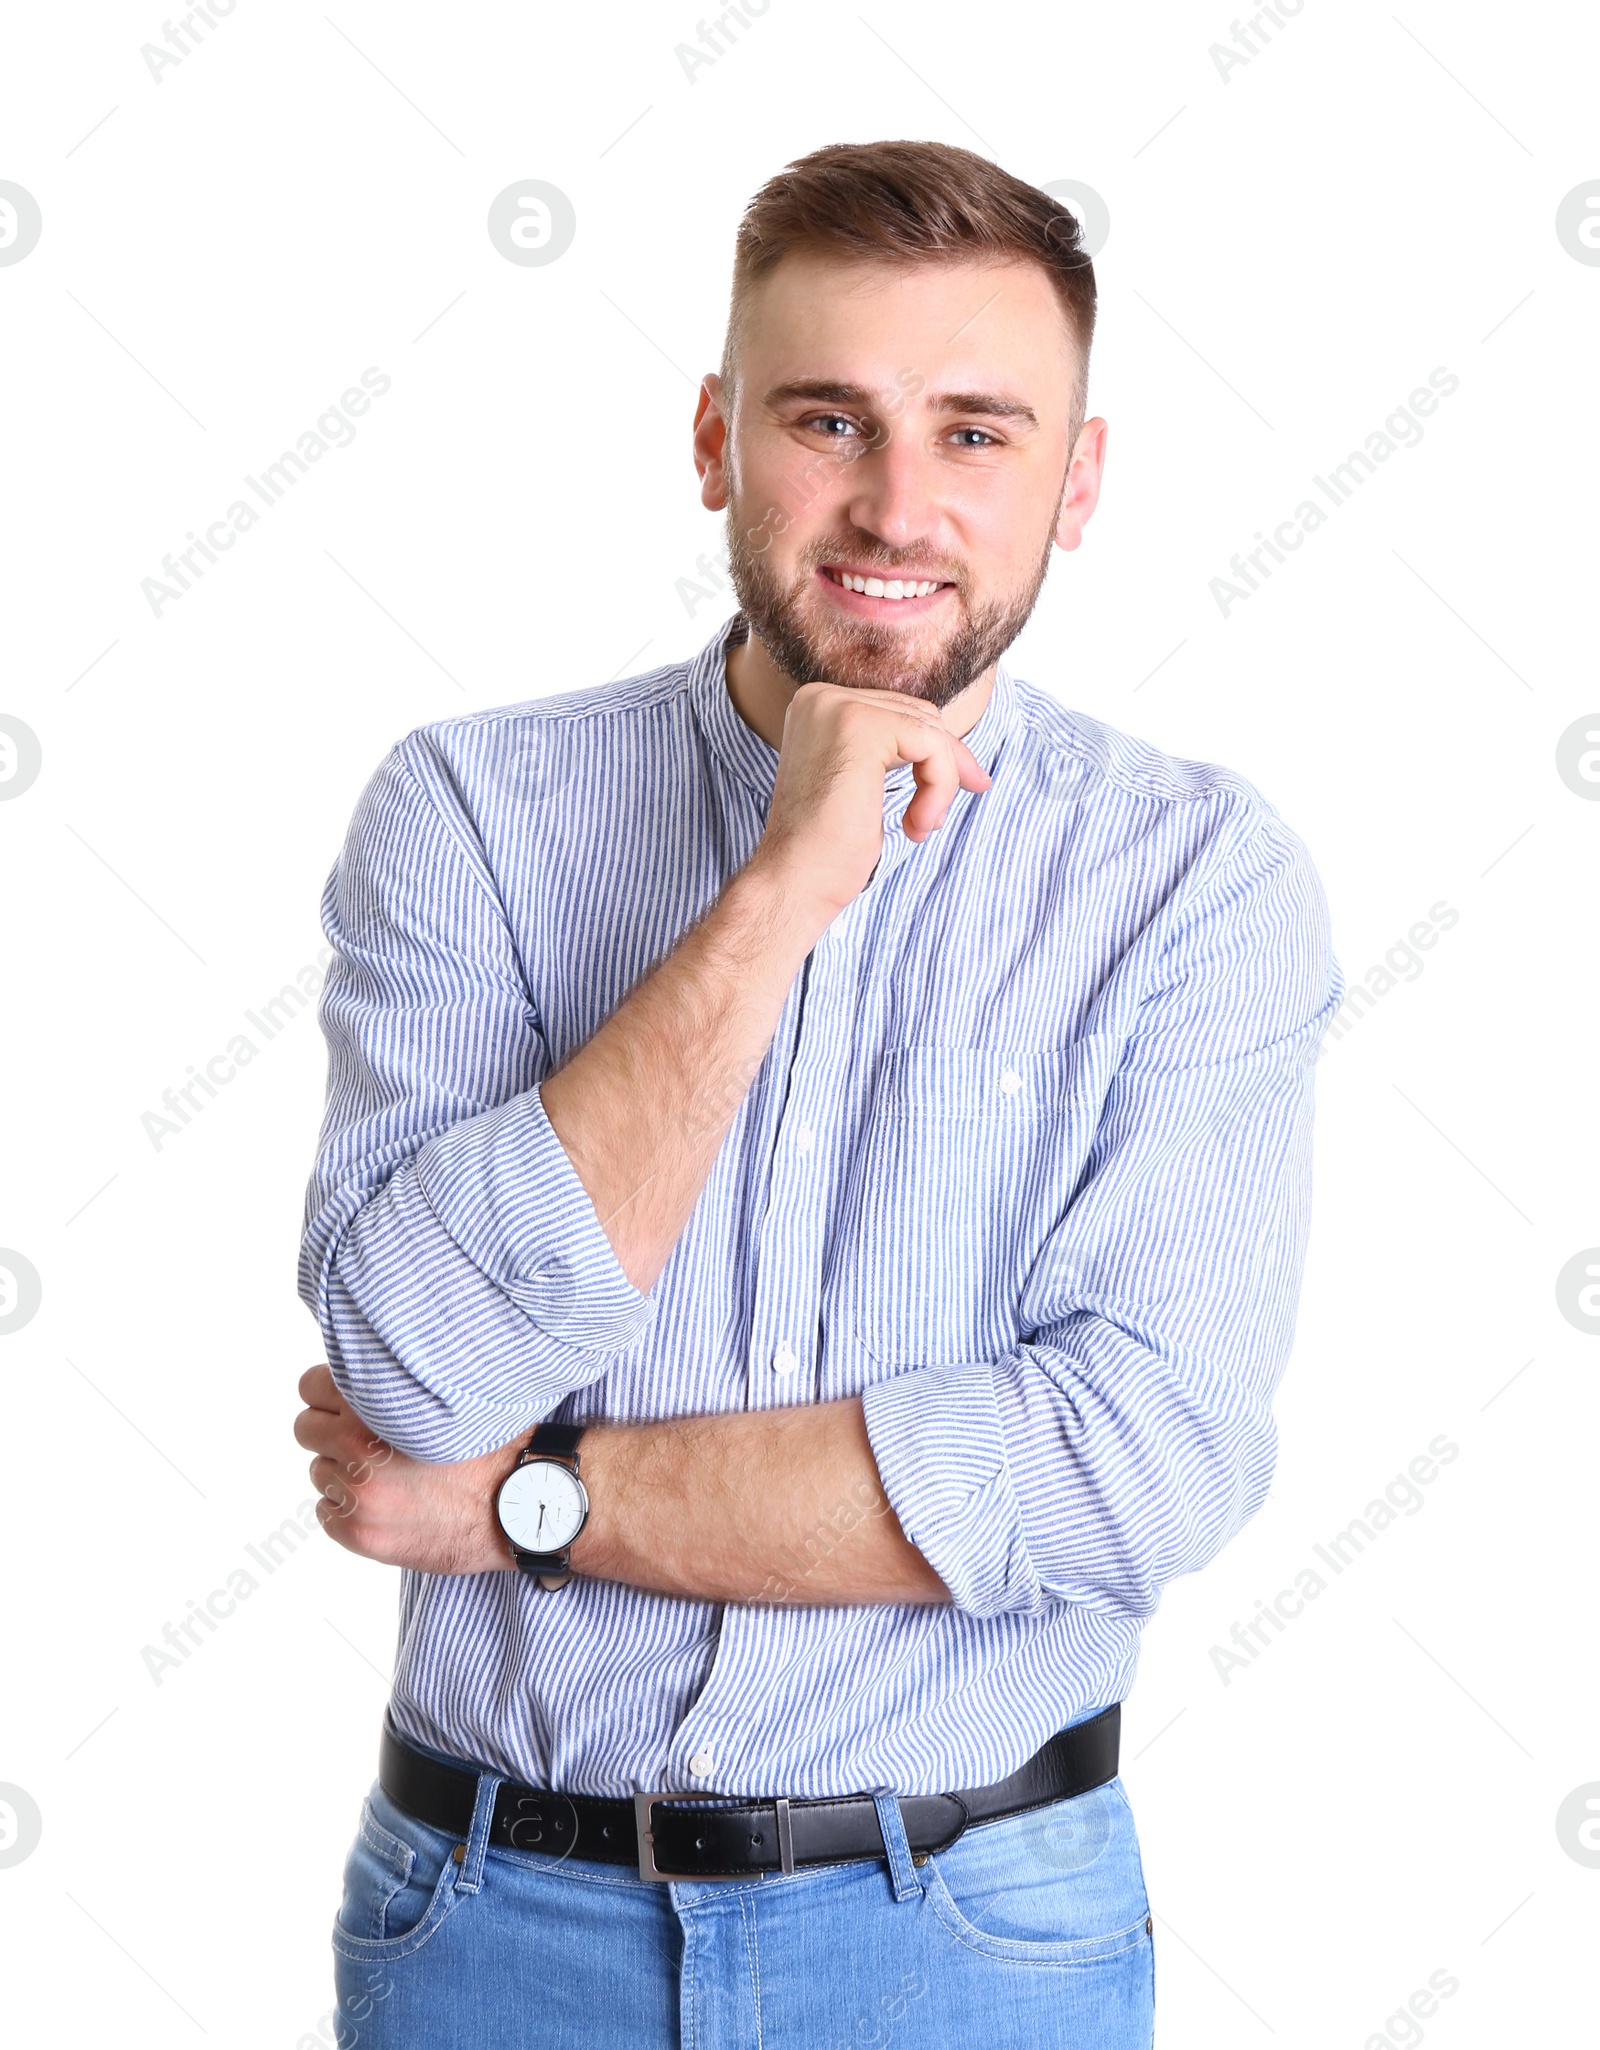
[841,1033,1116,1367]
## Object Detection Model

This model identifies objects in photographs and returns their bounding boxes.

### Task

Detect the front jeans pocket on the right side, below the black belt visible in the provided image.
[923,1779,1151,1966]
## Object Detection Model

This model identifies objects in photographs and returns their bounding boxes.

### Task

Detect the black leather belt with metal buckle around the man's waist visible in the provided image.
[377,1704,1122,1880]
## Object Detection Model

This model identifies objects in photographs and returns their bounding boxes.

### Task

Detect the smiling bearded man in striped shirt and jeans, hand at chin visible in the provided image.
[295,144,1342,2050]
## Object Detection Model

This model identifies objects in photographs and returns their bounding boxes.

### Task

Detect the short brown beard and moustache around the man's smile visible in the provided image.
[728,500,1054,711]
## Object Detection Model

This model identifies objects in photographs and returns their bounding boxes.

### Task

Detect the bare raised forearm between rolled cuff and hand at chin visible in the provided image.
[539,867,823,1292]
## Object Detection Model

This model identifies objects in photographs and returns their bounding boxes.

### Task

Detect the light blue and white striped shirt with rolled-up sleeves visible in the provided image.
[299,619,1344,1796]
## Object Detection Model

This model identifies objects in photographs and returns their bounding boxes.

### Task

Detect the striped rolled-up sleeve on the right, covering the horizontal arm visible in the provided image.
[864,814,1344,1620]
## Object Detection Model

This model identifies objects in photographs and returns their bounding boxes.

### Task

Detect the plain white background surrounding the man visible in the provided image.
[0,0,1600,2050]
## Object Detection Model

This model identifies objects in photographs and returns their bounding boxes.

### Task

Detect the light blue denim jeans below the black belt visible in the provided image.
[334,1773,1155,2050]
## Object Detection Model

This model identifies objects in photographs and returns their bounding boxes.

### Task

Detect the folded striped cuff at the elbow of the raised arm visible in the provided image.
[414,1089,656,1351]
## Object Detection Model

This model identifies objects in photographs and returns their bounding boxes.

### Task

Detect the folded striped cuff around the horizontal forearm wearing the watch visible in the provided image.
[862,1363,1050,1615]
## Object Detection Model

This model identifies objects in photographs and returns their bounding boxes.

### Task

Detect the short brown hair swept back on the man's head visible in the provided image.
[722,141,1095,437]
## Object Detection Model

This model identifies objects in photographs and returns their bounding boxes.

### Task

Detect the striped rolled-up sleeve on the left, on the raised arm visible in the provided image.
[299,734,654,1460]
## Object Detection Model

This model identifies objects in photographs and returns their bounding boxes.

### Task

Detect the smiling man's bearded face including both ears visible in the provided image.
[695,254,1104,707]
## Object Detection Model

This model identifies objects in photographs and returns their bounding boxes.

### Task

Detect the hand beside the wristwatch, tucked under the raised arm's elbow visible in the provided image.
[295,1367,517,1572]
